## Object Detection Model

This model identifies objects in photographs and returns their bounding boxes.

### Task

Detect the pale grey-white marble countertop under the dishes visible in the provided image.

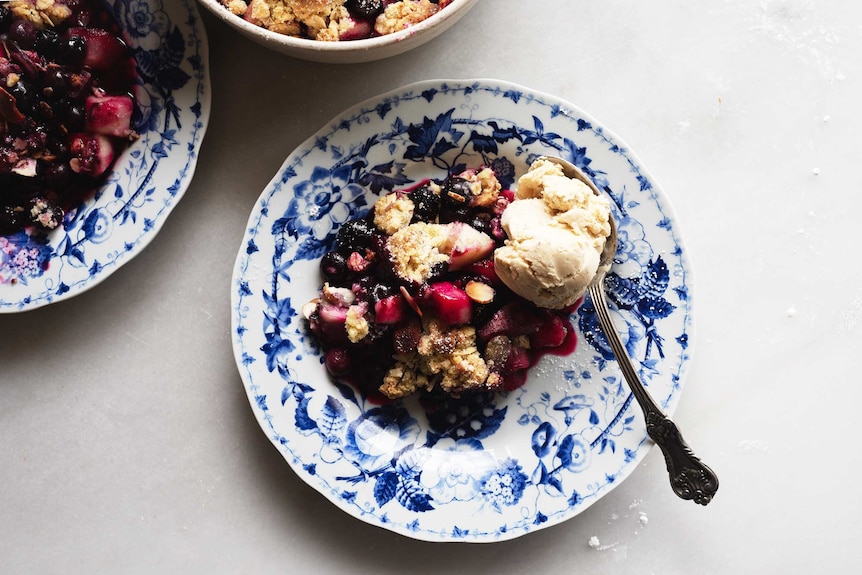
[0,0,862,575]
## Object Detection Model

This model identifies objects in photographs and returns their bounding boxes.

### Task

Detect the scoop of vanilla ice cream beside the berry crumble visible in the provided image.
[494,160,611,309]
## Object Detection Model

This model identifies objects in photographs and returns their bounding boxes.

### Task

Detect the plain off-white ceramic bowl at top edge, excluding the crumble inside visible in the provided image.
[199,0,477,64]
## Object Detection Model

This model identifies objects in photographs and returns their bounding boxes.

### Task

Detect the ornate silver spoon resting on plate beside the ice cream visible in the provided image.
[542,156,718,505]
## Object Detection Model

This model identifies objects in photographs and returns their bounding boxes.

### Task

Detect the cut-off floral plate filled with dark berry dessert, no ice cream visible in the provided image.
[0,0,209,312]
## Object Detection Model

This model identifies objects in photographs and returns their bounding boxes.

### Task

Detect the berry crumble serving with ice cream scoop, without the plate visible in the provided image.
[303,160,610,399]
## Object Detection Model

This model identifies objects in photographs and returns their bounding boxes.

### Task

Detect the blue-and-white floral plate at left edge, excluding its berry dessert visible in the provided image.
[0,0,210,313]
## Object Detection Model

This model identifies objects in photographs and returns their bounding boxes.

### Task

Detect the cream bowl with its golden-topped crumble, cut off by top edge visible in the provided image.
[200,0,476,64]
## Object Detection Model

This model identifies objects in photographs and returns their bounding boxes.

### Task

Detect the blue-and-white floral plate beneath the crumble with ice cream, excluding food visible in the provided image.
[231,80,692,542]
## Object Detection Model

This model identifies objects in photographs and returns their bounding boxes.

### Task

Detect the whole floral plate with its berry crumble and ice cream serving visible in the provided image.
[231,80,693,542]
